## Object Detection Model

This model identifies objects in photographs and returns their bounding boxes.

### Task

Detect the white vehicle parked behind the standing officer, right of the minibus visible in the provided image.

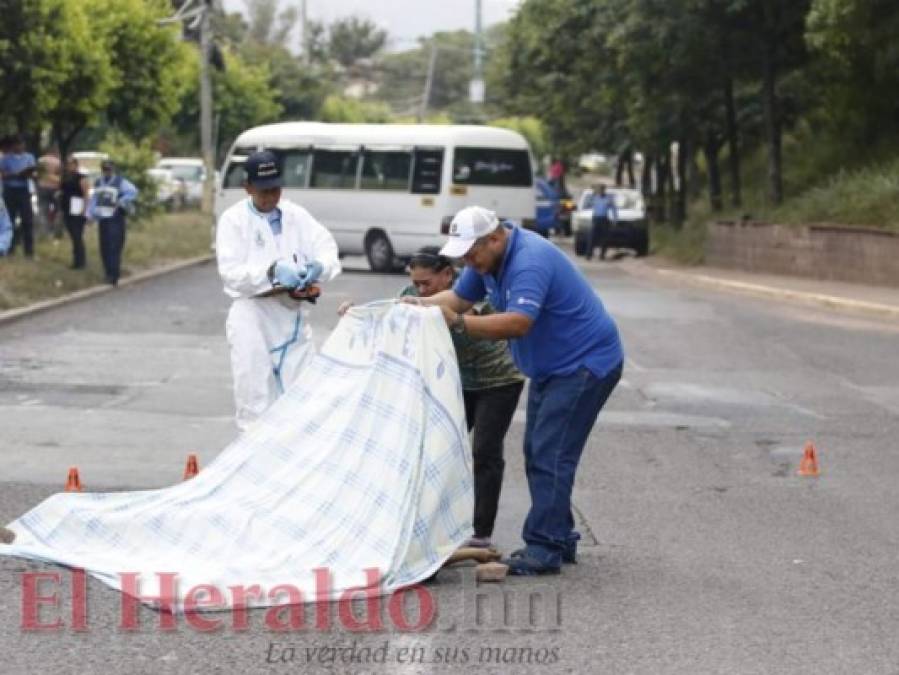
[573,188,649,256]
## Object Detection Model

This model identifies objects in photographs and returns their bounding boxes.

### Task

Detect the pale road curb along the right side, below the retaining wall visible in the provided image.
[622,264,899,319]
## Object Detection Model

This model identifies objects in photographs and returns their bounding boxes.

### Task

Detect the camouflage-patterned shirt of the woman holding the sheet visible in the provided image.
[400,284,525,391]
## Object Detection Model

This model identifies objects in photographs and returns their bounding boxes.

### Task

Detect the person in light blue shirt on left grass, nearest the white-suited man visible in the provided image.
[87,159,137,286]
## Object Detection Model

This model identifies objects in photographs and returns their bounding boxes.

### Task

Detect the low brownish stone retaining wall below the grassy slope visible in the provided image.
[705,222,899,287]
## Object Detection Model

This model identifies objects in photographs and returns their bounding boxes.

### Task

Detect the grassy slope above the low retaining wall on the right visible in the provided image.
[653,125,899,264]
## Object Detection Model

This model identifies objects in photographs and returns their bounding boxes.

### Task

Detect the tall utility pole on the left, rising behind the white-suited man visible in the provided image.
[158,0,215,213]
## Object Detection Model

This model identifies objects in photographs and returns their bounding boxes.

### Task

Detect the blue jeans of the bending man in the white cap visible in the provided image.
[521,363,623,567]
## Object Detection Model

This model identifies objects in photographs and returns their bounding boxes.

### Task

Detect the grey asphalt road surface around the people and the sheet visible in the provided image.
[0,251,899,674]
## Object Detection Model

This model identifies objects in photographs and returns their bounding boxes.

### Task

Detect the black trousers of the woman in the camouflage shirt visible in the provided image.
[462,382,524,537]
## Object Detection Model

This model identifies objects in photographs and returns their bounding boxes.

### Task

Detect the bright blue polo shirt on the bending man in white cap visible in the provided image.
[453,224,624,381]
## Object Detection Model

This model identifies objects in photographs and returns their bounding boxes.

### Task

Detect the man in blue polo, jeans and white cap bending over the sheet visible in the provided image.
[412,206,624,575]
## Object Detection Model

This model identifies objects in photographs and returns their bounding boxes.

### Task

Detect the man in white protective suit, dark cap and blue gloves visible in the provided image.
[216,152,340,430]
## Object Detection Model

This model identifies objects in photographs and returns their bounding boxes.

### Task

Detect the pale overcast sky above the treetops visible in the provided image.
[224,0,519,51]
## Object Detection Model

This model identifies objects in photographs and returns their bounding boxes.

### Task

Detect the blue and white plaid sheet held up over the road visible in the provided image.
[0,304,473,609]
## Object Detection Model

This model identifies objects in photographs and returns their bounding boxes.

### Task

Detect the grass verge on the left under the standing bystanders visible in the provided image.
[0,211,210,311]
